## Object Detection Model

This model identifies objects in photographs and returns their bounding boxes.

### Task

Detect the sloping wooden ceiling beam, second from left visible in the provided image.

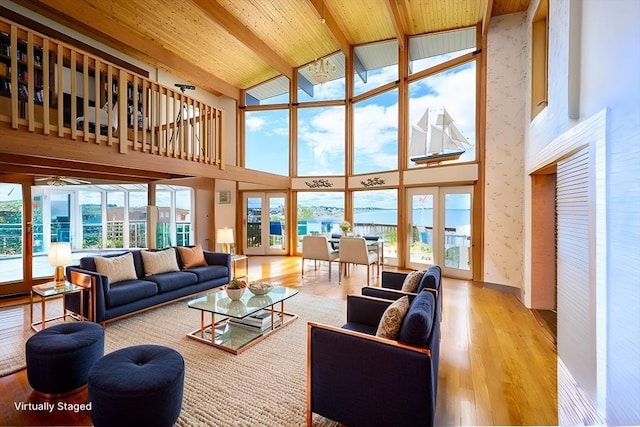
[192,0,293,80]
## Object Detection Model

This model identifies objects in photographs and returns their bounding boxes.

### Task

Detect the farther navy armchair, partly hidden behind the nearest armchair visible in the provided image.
[362,265,442,321]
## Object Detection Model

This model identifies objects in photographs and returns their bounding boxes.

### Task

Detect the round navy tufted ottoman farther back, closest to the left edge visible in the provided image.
[25,322,104,397]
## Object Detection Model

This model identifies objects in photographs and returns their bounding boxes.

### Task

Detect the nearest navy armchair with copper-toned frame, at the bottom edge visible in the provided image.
[307,291,440,427]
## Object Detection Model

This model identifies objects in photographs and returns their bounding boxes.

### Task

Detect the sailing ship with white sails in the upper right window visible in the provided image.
[409,108,471,164]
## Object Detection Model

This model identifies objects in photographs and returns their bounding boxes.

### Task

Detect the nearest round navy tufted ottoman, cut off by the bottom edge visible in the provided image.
[88,345,184,427]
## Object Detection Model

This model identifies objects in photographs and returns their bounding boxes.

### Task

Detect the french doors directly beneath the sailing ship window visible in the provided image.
[405,186,473,279]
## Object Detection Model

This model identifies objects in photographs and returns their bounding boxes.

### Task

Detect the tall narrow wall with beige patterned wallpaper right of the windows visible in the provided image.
[483,13,528,287]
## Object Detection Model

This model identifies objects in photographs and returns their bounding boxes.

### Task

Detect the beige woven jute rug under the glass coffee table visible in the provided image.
[2,293,346,427]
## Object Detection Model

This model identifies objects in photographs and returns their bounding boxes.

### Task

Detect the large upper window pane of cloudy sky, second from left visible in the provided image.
[298,106,345,176]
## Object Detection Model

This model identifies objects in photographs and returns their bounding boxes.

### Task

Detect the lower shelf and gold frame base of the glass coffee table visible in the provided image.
[187,308,298,354]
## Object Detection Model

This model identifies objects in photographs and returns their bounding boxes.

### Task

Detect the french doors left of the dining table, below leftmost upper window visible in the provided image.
[242,192,288,255]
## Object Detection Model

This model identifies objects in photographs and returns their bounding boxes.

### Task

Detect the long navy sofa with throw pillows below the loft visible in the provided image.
[65,250,231,324]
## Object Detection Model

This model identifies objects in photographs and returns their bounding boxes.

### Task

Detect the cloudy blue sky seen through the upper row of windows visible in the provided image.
[246,50,476,176]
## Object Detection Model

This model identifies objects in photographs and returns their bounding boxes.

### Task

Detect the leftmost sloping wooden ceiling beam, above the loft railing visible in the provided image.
[9,0,240,100]
